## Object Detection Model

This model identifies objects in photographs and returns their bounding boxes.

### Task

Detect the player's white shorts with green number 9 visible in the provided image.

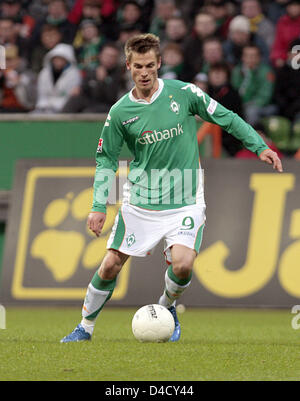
[107,204,205,263]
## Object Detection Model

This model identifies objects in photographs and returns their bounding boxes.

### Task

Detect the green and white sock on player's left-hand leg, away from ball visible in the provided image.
[81,272,116,335]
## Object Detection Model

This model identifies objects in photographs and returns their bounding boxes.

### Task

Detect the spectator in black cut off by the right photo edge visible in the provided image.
[275,38,300,122]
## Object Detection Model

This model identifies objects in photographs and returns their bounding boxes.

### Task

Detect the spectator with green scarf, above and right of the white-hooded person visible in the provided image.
[75,20,105,71]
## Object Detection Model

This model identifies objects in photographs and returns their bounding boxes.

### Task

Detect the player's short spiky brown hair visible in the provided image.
[124,33,160,62]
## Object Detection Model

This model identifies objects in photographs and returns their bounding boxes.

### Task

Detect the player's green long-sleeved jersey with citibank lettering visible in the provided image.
[92,79,268,212]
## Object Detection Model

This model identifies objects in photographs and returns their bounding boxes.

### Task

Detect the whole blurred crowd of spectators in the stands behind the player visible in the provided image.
[0,0,300,156]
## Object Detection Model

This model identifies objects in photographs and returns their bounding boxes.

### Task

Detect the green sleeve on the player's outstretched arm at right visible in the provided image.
[181,84,269,156]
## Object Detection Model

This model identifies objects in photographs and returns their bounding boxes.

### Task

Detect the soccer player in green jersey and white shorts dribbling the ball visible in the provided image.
[61,34,282,342]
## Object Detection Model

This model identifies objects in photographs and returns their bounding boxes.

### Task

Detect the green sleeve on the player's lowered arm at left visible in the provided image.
[92,109,124,213]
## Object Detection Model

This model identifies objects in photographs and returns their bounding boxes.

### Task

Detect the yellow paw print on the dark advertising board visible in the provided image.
[30,188,119,283]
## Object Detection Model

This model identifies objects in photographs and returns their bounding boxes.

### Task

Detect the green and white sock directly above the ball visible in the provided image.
[158,265,192,308]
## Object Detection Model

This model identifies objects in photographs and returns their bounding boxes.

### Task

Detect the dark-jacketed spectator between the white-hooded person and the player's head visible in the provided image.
[62,43,122,113]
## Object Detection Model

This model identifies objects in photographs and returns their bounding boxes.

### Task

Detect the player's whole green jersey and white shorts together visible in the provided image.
[92,79,268,256]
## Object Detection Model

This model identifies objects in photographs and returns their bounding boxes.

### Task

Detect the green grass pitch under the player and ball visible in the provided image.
[0,307,300,381]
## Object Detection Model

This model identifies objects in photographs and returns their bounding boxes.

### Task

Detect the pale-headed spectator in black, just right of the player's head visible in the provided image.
[184,12,217,81]
